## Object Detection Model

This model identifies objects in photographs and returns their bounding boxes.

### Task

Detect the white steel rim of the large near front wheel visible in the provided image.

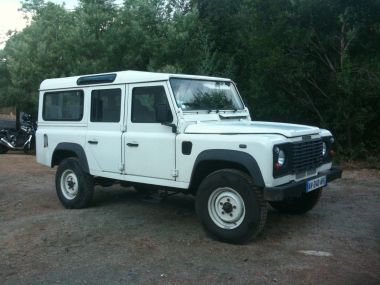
[208,187,245,230]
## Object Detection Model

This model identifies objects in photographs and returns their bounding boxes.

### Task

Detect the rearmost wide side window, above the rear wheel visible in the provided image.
[42,90,84,121]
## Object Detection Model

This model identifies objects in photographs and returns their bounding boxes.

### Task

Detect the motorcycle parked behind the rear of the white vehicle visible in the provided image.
[0,113,37,154]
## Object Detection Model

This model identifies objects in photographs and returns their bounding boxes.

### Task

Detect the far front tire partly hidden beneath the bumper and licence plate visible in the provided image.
[269,188,322,215]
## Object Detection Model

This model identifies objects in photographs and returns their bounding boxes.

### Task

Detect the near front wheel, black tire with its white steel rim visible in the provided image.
[195,169,267,244]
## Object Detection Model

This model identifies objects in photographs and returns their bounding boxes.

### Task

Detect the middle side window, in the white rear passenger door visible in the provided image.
[91,89,121,123]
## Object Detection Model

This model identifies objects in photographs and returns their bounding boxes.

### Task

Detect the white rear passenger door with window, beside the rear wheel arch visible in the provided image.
[86,85,125,173]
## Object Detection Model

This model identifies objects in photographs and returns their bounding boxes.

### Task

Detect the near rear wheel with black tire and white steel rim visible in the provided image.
[55,157,94,209]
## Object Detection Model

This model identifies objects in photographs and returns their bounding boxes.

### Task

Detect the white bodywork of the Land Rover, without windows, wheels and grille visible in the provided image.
[36,71,331,191]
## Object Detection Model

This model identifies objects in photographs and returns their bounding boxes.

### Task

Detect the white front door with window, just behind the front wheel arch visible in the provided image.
[123,82,176,180]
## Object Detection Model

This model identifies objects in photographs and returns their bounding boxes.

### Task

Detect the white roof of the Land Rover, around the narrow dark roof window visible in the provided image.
[40,70,230,90]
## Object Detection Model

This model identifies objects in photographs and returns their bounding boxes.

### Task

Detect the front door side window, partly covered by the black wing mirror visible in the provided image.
[131,86,173,123]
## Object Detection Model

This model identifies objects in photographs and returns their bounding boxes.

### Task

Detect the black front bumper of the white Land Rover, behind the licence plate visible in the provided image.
[264,167,342,201]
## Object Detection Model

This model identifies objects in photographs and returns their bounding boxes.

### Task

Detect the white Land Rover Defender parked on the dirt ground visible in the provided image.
[36,71,342,243]
